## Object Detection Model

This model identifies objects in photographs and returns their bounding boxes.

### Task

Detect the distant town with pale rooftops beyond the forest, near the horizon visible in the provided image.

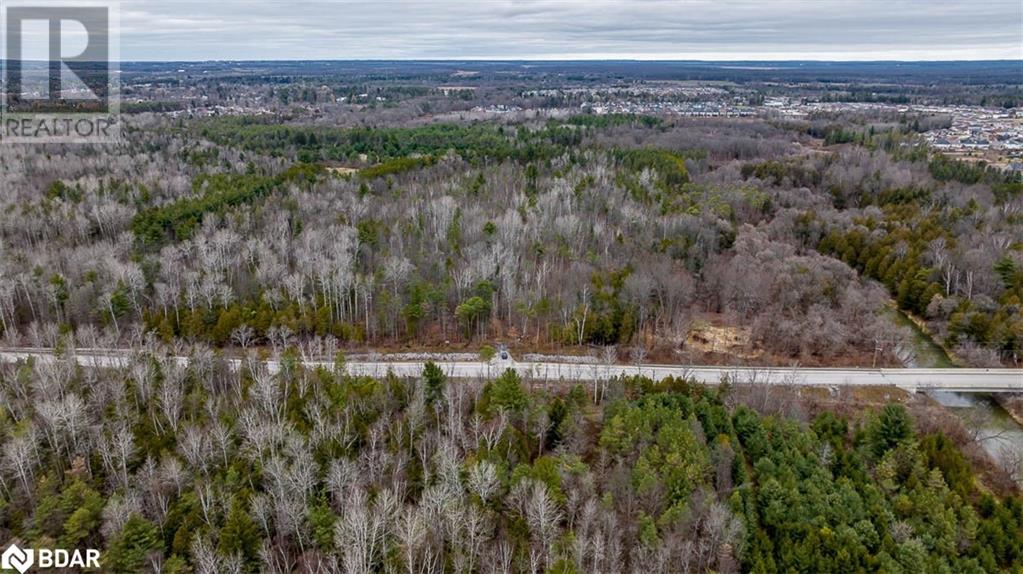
[124,69,1023,173]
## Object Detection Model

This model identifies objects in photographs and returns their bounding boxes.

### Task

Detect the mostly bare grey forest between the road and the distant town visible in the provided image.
[0,105,1023,365]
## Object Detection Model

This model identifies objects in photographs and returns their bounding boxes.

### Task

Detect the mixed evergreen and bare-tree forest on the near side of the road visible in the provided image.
[0,342,1023,573]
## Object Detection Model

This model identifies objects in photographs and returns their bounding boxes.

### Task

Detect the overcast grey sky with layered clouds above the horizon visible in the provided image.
[121,0,1023,60]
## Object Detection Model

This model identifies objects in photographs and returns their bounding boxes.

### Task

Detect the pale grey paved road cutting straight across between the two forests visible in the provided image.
[0,349,1023,392]
